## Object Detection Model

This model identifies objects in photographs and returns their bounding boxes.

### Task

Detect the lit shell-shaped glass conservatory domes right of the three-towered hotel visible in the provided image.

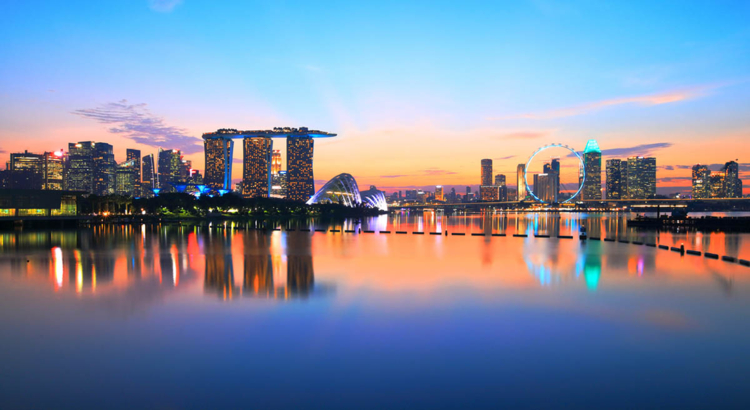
[307,174,388,211]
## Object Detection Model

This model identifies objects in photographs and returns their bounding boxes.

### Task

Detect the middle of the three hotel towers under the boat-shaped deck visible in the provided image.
[242,137,273,198]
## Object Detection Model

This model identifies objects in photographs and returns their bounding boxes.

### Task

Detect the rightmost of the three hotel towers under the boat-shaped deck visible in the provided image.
[286,136,315,202]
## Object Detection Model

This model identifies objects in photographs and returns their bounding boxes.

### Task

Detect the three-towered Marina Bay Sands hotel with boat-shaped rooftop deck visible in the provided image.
[203,127,336,201]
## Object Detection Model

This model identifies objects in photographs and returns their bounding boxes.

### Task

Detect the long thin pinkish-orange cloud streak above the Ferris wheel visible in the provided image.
[488,84,727,121]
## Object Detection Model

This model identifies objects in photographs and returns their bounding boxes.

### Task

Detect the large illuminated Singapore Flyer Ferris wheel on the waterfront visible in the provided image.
[523,144,586,204]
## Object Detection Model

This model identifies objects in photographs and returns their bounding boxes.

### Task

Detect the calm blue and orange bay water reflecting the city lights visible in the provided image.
[0,212,750,408]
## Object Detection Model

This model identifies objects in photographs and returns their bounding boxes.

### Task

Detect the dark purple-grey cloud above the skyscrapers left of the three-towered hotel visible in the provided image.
[72,100,203,154]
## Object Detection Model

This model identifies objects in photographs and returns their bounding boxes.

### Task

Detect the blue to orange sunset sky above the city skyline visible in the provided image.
[0,0,750,193]
